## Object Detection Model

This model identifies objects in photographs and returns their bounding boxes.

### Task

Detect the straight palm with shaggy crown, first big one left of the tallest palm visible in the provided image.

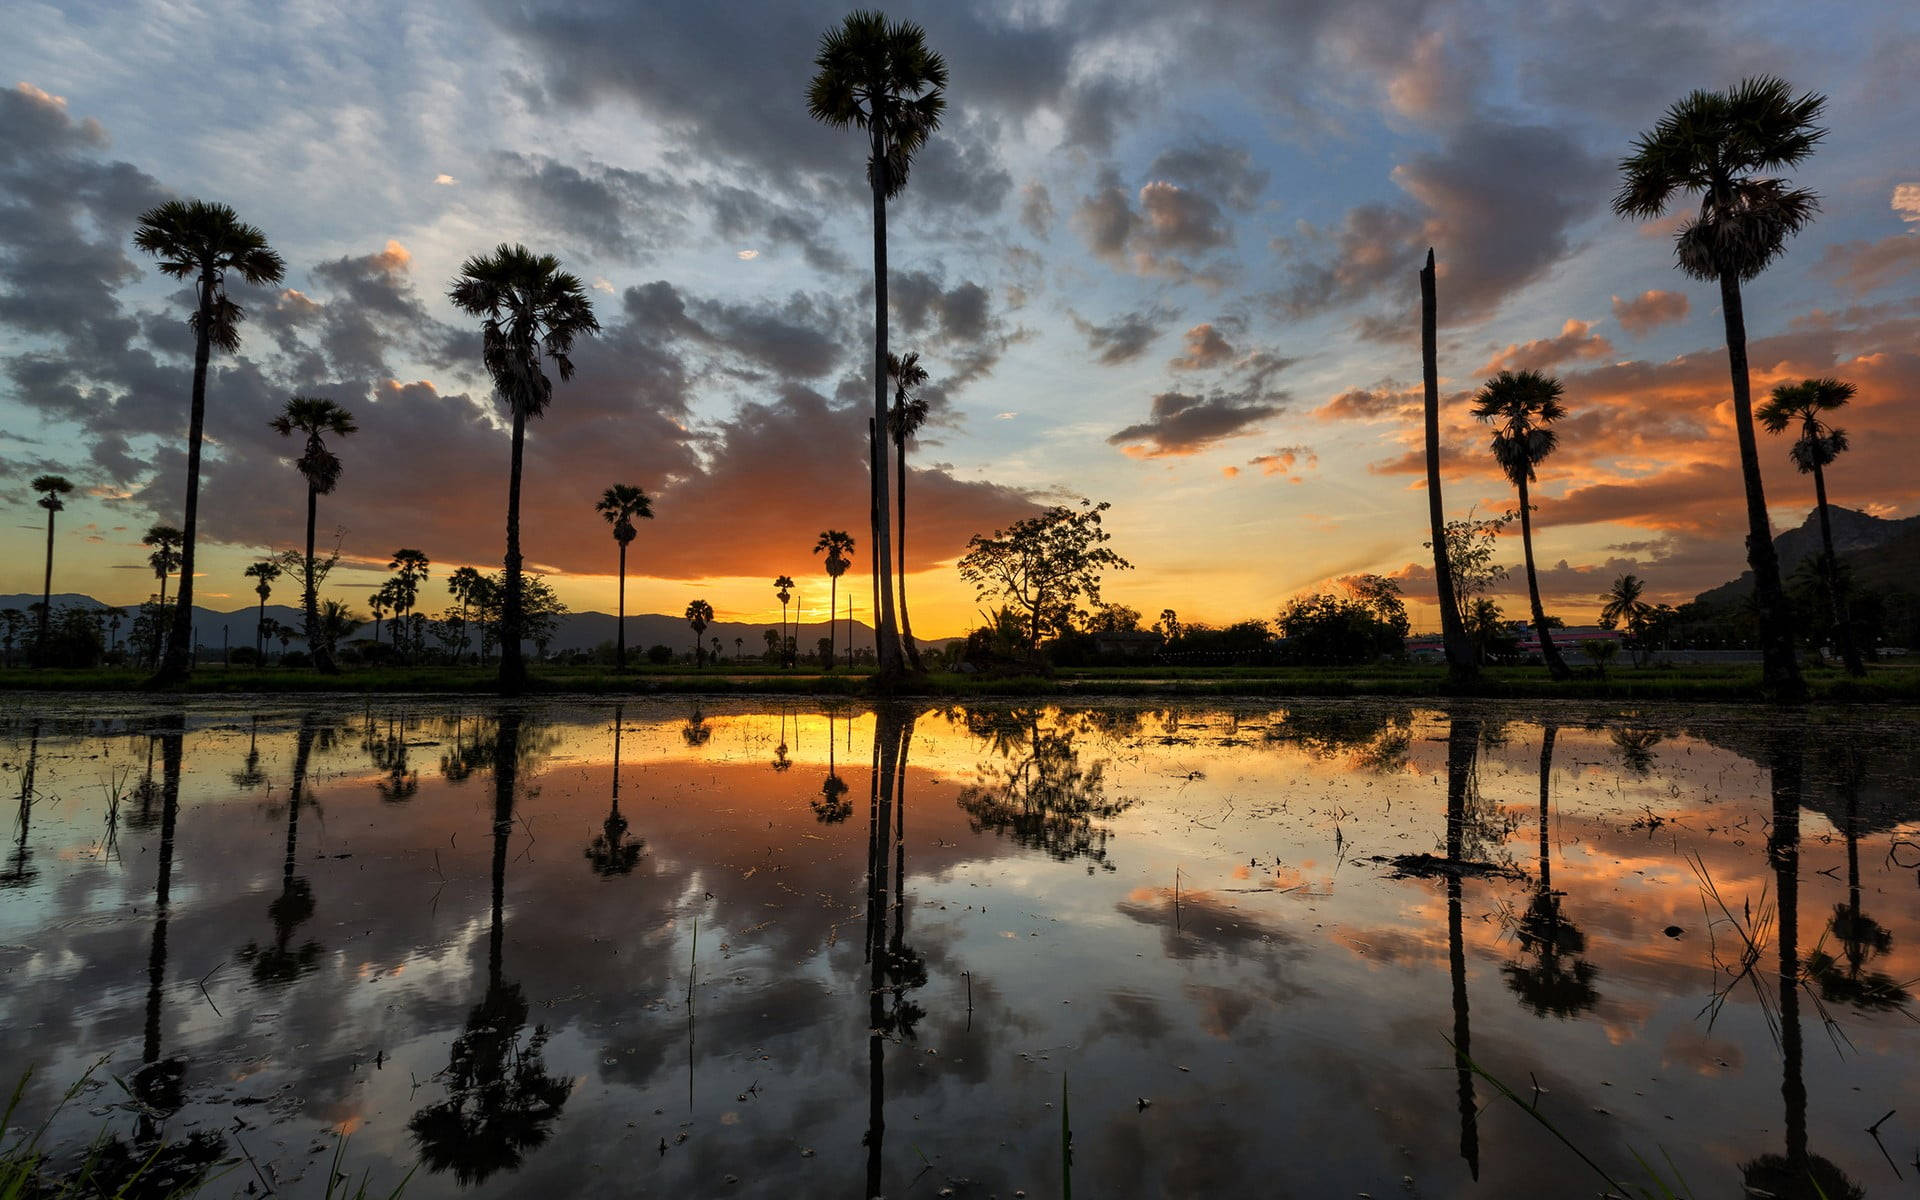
[447,242,599,695]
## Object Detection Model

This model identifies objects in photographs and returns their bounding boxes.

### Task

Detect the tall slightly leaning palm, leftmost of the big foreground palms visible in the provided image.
[132,200,286,684]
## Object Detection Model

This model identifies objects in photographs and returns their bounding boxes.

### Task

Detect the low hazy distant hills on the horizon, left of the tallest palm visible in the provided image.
[0,591,947,657]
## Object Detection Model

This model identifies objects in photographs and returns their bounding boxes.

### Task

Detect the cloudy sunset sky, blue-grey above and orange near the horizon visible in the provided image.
[0,0,1920,636]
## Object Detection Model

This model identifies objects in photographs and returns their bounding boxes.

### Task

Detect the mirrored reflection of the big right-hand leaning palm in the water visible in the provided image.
[1740,733,1866,1200]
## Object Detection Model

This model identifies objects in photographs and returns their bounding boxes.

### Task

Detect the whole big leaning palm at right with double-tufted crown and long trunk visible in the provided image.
[1613,75,1826,699]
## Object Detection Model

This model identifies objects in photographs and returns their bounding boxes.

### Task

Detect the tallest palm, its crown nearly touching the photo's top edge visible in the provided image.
[806,12,947,680]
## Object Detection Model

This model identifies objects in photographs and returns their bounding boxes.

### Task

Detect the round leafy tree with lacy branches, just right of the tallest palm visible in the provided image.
[960,499,1133,655]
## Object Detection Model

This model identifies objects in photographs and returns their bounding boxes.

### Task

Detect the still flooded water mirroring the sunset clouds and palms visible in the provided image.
[0,697,1920,1198]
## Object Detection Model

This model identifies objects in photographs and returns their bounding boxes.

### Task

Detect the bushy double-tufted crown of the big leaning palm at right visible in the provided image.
[1613,75,1826,280]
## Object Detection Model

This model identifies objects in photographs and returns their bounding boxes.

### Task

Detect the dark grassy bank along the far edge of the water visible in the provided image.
[0,664,1920,705]
